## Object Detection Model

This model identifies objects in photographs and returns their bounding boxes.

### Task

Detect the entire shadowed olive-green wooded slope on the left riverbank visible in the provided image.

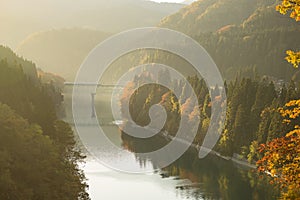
[0,47,89,200]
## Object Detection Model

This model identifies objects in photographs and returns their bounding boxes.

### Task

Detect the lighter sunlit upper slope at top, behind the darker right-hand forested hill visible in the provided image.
[159,0,276,36]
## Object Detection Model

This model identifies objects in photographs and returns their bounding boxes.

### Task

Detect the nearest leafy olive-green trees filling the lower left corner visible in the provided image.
[0,103,89,200]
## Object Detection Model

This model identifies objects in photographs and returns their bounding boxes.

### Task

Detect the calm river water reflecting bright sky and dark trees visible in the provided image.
[65,86,277,200]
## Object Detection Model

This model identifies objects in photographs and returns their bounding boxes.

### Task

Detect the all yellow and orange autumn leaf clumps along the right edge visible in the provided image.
[257,3,300,199]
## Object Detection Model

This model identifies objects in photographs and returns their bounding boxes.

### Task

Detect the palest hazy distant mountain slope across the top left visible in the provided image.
[0,0,183,49]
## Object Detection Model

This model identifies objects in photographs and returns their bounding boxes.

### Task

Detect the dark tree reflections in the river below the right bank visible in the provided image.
[122,133,278,200]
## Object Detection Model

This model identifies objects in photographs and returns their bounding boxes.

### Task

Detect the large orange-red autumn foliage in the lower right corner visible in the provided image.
[257,99,300,199]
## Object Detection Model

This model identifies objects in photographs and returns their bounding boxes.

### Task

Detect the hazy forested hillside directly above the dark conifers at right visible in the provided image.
[196,27,300,81]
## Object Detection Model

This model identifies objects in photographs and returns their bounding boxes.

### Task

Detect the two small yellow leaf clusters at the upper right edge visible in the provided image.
[276,0,300,68]
